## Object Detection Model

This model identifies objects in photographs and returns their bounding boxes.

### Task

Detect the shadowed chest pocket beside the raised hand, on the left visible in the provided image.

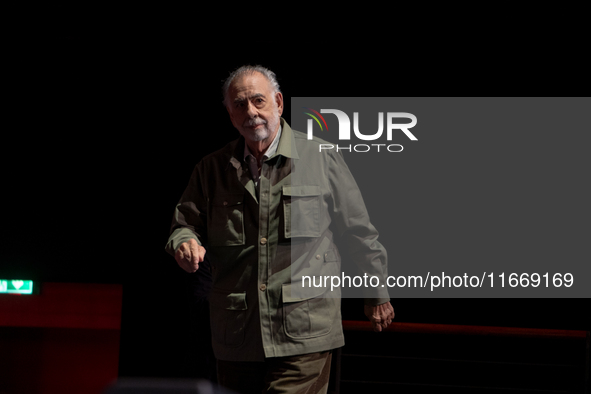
[207,193,244,246]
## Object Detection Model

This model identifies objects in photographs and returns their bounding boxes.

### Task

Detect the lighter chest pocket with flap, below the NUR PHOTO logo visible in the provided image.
[283,185,321,238]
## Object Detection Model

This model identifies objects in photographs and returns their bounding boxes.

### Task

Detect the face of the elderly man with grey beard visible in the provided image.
[226,72,283,143]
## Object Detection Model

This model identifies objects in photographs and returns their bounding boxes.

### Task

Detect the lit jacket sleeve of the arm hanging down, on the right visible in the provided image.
[328,152,390,306]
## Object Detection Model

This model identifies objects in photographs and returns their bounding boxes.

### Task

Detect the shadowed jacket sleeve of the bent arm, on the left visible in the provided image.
[165,164,207,256]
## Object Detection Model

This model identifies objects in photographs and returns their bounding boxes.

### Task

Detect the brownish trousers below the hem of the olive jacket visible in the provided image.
[217,351,332,394]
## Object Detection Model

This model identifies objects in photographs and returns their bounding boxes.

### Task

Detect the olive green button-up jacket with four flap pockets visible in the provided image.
[166,119,389,361]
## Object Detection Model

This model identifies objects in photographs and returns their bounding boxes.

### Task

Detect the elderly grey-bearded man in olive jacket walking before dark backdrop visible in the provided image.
[166,66,394,393]
